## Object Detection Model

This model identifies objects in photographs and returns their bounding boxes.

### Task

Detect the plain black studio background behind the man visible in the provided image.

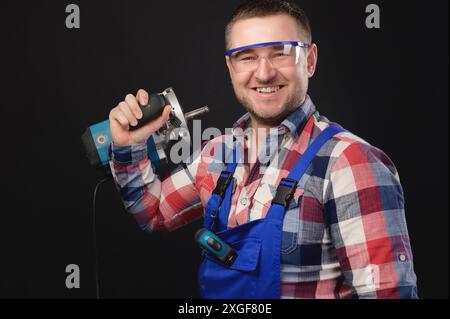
[0,0,449,298]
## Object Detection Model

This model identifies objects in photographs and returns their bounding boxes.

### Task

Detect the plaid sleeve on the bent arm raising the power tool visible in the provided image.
[109,143,203,232]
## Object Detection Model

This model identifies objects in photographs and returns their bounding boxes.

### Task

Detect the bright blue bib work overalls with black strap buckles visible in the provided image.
[199,126,345,299]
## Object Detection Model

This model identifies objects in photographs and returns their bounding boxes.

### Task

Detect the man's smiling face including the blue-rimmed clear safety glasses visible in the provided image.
[226,11,317,128]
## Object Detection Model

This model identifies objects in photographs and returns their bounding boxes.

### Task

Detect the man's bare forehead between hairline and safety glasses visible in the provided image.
[229,14,301,48]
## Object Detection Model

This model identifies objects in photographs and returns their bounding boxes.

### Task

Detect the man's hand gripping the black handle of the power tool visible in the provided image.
[109,89,172,146]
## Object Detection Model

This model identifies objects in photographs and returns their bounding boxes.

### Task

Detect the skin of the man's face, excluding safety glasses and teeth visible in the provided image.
[226,14,317,126]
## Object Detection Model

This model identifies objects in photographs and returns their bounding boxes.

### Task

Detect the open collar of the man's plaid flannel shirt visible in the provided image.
[232,95,316,140]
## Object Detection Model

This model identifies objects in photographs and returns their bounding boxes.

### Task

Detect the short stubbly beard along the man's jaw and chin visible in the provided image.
[236,92,304,127]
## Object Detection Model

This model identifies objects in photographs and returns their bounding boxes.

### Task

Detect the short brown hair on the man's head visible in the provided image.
[225,0,312,49]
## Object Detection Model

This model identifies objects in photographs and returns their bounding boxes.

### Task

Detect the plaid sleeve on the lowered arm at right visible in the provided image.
[325,142,417,299]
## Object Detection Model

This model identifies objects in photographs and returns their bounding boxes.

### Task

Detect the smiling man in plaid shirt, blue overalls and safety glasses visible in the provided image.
[110,0,417,298]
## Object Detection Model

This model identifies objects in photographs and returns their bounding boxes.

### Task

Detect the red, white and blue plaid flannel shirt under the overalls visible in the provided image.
[110,96,417,298]
